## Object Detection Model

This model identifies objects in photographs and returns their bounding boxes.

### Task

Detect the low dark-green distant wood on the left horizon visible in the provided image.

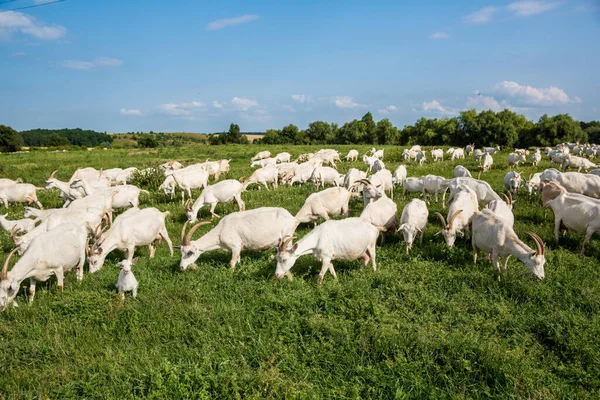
[19,128,113,147]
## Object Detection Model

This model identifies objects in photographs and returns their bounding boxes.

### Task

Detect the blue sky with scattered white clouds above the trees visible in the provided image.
[0,0,600,132]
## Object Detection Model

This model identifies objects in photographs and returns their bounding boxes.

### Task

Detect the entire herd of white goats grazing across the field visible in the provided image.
[0,143,600,310]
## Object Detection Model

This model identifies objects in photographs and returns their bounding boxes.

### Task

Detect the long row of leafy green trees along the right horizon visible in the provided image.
[254,110,600,147]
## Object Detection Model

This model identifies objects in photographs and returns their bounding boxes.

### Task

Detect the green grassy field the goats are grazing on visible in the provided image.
[0,145,600,399]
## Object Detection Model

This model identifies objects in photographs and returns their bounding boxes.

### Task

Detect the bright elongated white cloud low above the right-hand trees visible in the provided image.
[491,81,581,106]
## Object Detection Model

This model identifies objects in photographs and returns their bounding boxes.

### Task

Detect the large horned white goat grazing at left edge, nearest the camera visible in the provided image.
[0,224,87,311]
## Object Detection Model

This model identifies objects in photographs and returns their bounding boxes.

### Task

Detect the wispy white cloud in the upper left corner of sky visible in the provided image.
[0,11,67,40]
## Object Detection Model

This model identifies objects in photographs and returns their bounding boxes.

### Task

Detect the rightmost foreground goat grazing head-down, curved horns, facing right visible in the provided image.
[471,209,546,280]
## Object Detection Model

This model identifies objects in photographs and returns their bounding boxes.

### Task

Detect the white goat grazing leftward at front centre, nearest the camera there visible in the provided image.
[275,218,379,285]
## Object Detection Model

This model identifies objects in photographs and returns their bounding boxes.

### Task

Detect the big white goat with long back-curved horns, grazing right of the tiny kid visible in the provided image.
[179,207,298,271]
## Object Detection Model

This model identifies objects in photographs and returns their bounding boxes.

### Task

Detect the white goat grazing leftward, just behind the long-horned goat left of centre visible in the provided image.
[185,179,246,223]
